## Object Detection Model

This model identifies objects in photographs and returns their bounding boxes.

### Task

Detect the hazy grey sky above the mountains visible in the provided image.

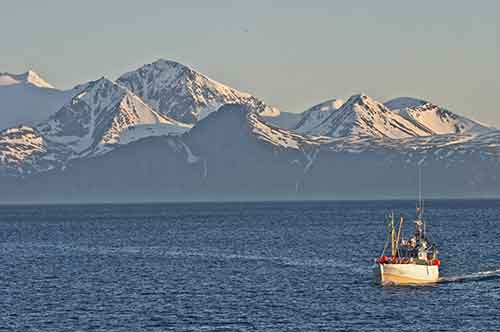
[0,0,500,127]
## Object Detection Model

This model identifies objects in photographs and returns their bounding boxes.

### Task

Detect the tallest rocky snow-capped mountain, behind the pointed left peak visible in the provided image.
[117,60,278,124]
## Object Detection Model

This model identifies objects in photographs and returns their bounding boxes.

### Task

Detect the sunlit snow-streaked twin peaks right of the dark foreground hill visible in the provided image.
[293,94,495,139]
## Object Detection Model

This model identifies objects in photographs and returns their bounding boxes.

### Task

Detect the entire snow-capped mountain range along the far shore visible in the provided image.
[0,60,500,202]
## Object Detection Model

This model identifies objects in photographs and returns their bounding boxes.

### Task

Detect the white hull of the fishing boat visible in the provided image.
[375,264,439,285]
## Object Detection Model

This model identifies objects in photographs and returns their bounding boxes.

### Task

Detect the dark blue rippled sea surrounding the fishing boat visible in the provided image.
[0,200,500,331]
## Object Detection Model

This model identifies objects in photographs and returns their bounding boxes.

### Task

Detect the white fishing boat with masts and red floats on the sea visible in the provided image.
[374,200,441,285]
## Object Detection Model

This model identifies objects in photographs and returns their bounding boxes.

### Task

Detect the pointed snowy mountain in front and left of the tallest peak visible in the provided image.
[37,78,190,157]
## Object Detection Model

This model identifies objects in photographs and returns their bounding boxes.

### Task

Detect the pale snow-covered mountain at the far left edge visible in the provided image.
[0,70,79,130]
